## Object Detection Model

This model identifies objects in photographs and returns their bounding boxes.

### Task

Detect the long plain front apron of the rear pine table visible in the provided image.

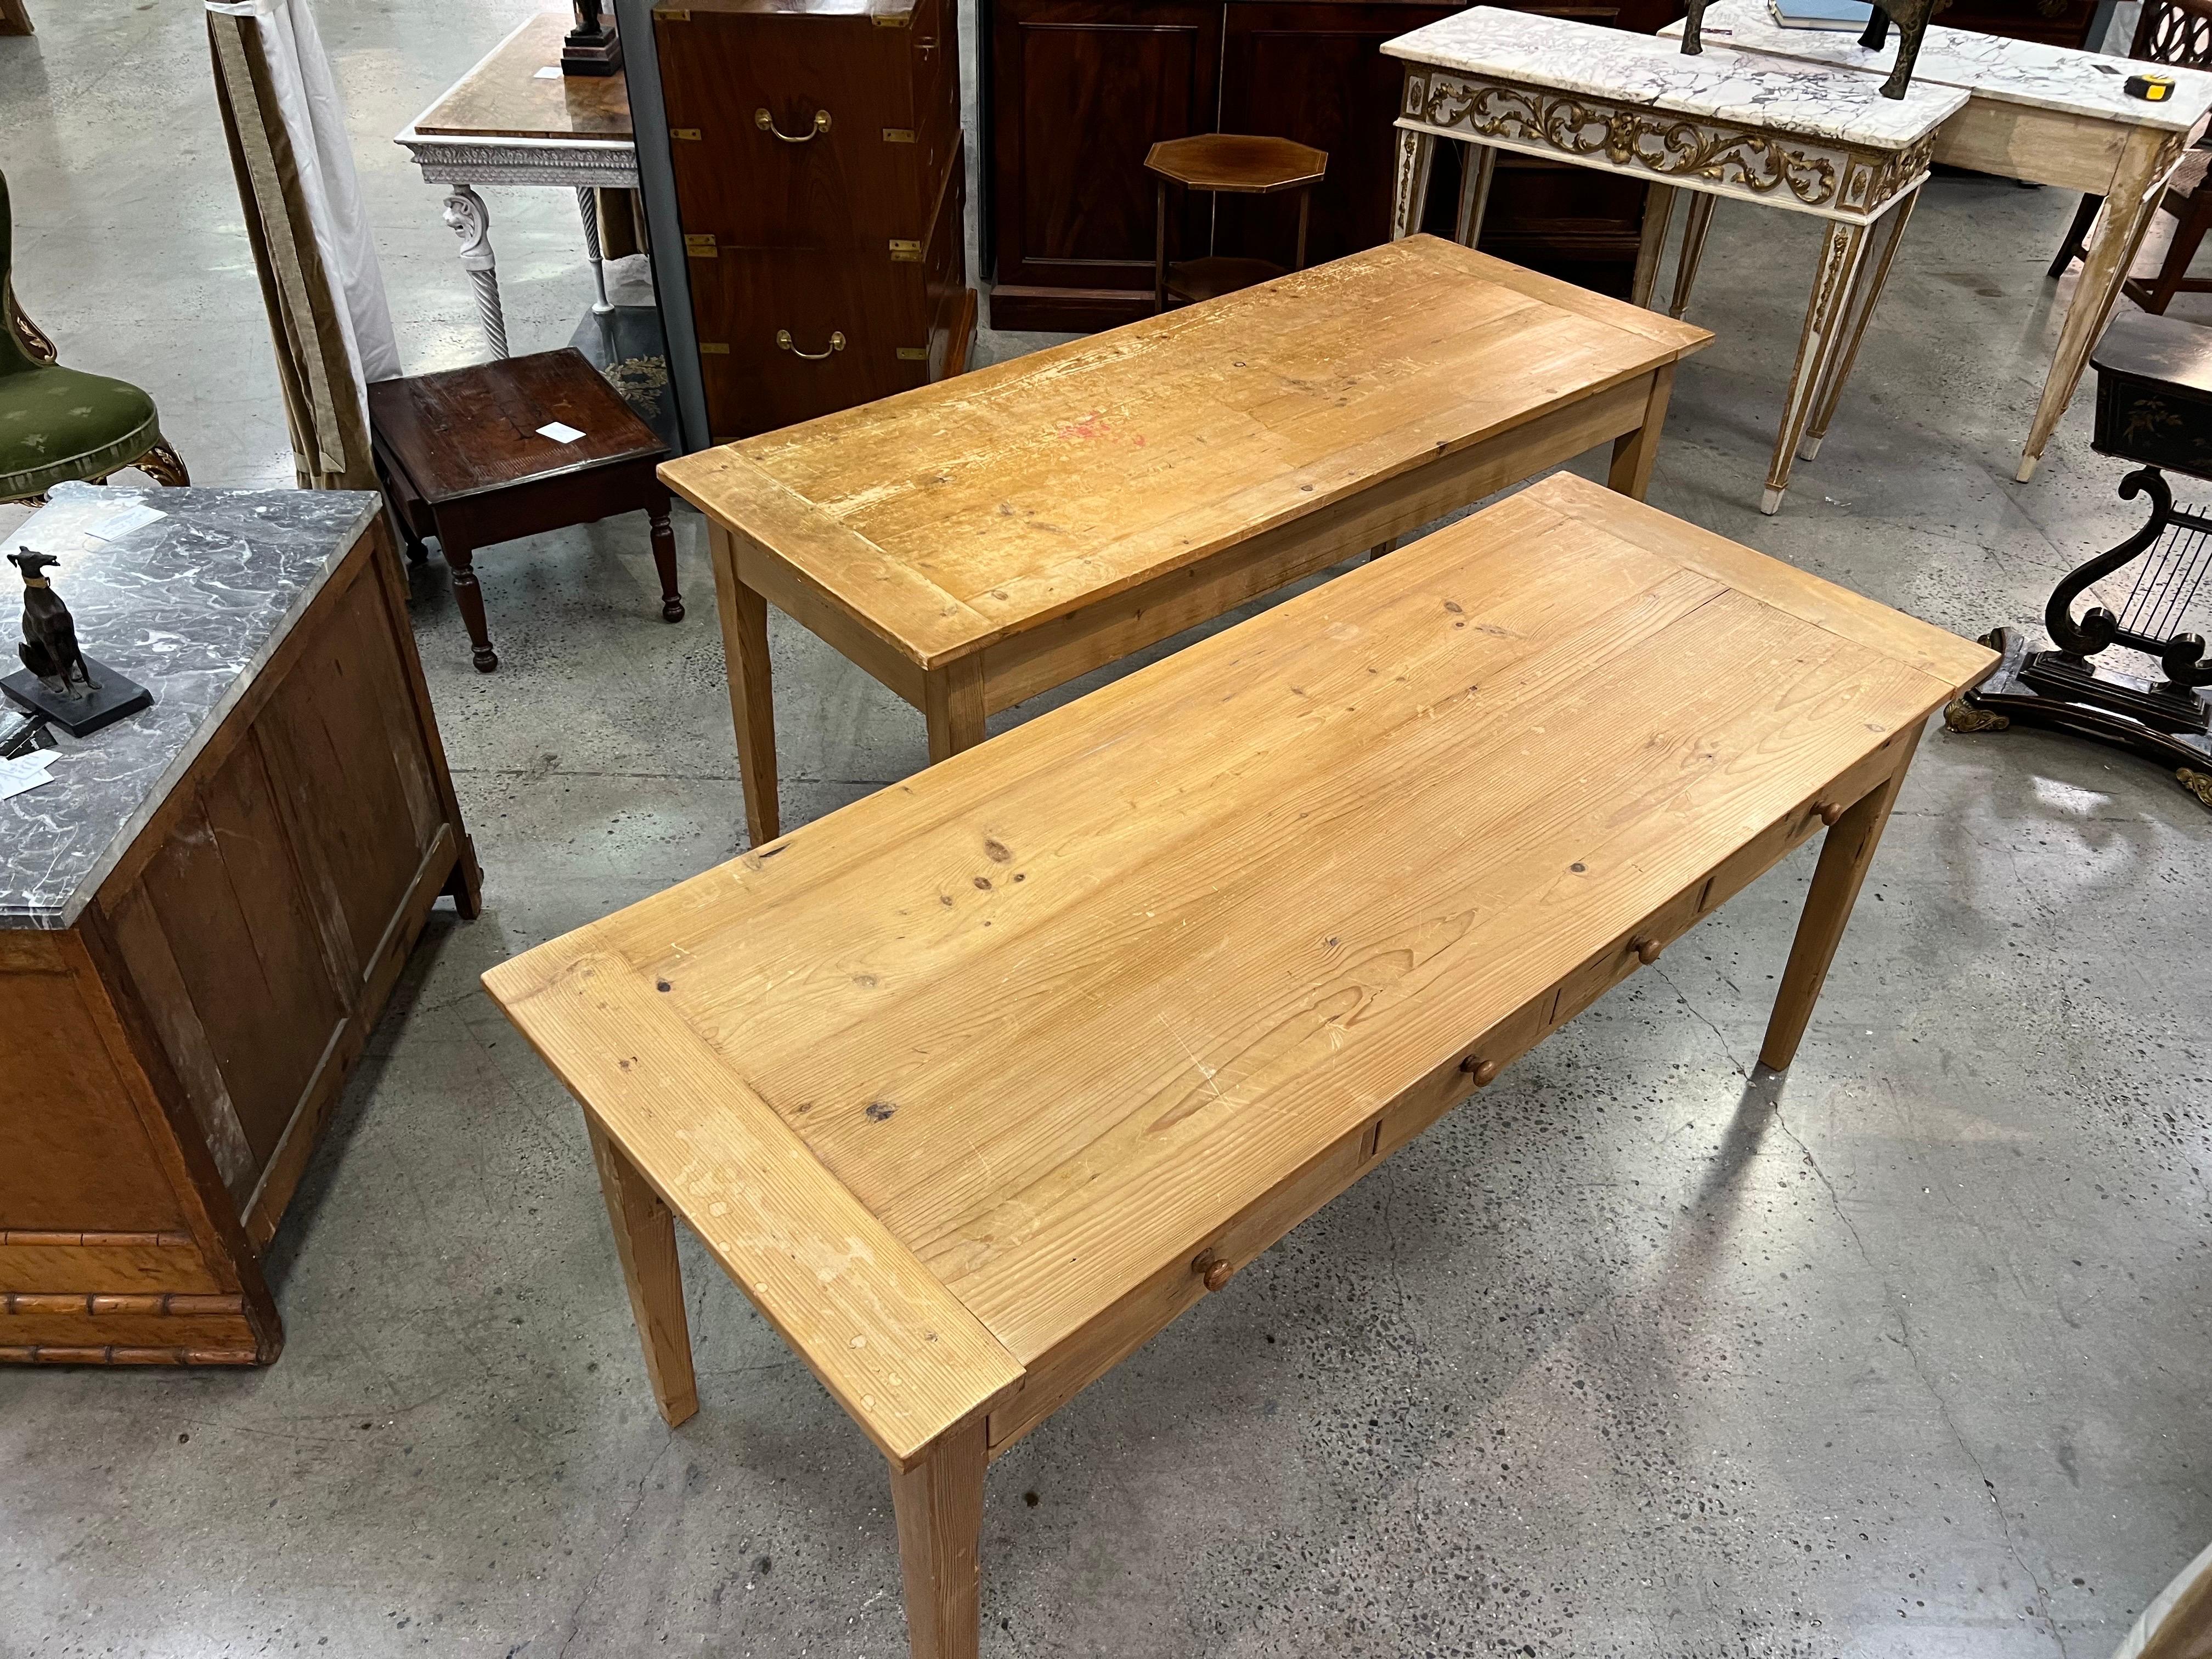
[978,369,1657,712]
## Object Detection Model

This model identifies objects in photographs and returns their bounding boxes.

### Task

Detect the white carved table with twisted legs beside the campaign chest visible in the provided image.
[396,9,637,356]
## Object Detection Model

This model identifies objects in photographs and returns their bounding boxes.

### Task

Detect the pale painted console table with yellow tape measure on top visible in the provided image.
[1672,0,2212,482]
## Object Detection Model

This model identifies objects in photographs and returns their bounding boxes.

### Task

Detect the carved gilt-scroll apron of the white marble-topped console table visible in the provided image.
[1396,64,1938,223]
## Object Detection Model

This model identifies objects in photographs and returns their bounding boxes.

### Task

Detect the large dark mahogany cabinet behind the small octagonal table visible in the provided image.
[982,0,1679,330]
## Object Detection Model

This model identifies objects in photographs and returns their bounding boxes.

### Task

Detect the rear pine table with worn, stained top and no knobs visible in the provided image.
[662,236,1712,845]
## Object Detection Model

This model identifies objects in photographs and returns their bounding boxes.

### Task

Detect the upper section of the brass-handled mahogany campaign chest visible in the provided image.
[657,0,960,248]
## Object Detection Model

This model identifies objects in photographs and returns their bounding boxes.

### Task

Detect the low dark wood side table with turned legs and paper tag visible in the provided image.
[369,347,684,675]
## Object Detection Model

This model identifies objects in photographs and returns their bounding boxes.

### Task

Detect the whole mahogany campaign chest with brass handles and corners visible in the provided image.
[652,0,975,442]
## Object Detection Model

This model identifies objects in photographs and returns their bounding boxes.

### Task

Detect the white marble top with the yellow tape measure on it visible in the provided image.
[1663,0,2212,131]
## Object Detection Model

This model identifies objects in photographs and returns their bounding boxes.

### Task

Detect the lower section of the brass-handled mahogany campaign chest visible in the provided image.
[690,150,967,442]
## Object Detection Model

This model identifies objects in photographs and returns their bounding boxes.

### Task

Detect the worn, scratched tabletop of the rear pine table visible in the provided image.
[662,236,1712,668]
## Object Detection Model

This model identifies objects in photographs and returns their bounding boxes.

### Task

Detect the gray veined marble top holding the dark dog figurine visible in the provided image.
[0,484,383,929]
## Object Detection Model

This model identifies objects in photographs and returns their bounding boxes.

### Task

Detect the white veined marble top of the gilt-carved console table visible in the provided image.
[1383,7,1966,150]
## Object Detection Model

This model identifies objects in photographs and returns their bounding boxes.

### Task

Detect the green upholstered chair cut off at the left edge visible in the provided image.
[0,175,193,502]
